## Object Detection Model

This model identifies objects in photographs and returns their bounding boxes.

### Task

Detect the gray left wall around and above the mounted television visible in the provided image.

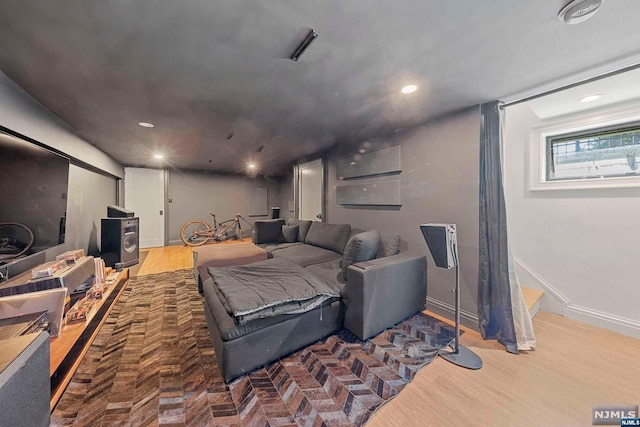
[0,72,124,275]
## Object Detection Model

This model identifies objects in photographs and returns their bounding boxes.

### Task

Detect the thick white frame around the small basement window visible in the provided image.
[527,101,640,191]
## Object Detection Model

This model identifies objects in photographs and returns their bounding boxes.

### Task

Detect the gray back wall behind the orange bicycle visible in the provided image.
[168,170,281,245]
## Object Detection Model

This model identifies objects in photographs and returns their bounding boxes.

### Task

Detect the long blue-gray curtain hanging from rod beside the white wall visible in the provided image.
[478,101,518,354]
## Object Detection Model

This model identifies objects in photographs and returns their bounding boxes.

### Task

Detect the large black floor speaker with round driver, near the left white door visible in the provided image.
[101,218,140,267]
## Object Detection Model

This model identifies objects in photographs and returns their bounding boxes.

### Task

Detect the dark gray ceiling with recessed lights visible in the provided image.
[0,0,640,175]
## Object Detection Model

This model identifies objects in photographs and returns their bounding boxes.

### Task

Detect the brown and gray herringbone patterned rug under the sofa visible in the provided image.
[51,270,453,427]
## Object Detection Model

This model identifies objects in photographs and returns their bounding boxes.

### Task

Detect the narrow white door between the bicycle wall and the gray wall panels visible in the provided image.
[298,159,323,221]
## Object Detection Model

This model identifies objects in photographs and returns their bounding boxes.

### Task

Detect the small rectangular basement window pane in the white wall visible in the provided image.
[546,122,640,181]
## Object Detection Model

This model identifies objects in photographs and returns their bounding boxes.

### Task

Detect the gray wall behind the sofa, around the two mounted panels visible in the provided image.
[327,108,480,329]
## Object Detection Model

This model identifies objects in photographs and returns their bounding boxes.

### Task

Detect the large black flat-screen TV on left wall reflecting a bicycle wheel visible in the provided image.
[0,127,69,272]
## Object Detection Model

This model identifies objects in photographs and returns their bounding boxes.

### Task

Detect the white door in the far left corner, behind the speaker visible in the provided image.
[124,168,165,248]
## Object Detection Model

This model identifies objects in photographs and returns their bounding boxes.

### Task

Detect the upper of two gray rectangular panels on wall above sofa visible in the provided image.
[336,146,402,179]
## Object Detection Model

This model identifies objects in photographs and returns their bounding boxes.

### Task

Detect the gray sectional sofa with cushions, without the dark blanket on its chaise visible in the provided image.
[201,219,426,382]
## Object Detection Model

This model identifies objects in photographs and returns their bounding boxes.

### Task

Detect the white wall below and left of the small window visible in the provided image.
[504,104,640,337]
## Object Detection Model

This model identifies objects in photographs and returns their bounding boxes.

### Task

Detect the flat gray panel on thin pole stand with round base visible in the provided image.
[420,224,482,369]
